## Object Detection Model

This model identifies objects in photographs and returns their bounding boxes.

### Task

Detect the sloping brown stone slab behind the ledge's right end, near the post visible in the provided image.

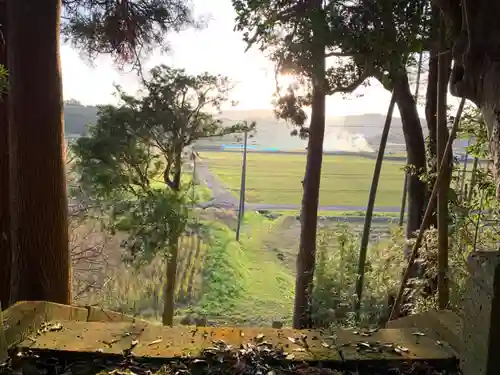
[387,310,463,354]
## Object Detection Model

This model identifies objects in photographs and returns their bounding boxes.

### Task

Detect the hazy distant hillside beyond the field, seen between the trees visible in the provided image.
[64,104,466,152]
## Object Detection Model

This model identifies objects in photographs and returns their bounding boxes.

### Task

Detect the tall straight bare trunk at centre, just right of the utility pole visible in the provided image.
[293,0,326,329]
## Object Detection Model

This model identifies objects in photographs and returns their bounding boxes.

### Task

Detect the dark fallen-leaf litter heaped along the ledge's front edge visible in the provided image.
[0,335,459,375]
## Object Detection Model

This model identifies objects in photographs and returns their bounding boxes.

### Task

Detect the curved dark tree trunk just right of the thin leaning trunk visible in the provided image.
[394,72,426,254]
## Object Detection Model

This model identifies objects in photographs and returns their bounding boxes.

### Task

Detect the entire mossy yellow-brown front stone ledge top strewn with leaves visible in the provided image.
[20,321,456,364]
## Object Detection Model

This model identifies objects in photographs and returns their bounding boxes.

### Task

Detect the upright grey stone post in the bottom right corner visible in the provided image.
[460,251,500,375]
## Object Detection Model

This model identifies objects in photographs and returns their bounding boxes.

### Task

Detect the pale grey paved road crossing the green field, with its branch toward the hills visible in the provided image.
[196,158,400,212]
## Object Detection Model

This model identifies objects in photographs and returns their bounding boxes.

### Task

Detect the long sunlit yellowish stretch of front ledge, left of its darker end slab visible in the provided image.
[16,322,341,362]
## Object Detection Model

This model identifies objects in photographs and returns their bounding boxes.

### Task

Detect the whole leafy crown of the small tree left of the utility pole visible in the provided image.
[72,65,255,259]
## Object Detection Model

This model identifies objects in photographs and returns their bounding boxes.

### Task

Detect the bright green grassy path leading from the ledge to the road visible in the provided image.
[198,214,294,325]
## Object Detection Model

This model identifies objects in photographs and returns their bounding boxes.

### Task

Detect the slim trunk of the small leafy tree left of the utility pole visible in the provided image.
[162,148,182,326]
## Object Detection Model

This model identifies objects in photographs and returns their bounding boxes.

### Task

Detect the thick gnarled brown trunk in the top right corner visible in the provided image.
[433,0,500,199]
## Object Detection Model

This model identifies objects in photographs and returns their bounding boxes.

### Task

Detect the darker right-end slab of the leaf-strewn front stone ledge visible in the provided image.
[336,328,456,362]
